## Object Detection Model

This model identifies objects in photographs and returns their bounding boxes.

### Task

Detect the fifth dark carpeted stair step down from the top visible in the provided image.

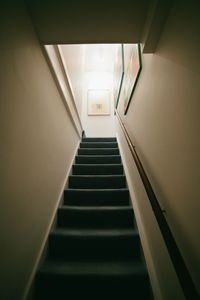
[72,164,123,175]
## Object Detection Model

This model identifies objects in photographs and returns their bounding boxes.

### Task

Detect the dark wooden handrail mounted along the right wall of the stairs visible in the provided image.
[116,111,200,300]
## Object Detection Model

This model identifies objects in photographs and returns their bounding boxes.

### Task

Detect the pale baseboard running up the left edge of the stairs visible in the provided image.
[22,141,80,300]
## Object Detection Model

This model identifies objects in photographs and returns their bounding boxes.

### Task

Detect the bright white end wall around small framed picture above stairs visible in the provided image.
[82,44,116,137]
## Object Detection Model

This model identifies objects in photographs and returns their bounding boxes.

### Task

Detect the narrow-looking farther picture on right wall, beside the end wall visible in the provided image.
[114,44,124,109]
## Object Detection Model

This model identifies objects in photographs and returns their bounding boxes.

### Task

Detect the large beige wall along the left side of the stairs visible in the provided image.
[0,1,79,300]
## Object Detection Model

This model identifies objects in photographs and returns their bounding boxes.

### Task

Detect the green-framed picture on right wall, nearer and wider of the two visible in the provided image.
[123,44,142,114]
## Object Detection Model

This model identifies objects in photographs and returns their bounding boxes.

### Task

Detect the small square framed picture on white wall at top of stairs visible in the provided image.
[87,90,110,116]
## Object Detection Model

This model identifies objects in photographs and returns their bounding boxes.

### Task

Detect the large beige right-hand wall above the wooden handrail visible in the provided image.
[116,1,200,291]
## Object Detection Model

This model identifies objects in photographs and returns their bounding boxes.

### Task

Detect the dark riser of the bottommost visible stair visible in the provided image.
[36,274,151,300]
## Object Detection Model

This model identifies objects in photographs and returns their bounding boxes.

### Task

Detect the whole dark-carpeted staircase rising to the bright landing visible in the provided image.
[35,138,151,300]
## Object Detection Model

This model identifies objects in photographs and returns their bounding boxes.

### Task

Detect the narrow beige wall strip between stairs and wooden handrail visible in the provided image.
[117,124,185,300]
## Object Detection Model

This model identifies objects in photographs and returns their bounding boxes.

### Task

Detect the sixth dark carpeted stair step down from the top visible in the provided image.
[69,175,126,189]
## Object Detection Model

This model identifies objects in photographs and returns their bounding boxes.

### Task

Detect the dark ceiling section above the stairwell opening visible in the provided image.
[26,0,151,44]
